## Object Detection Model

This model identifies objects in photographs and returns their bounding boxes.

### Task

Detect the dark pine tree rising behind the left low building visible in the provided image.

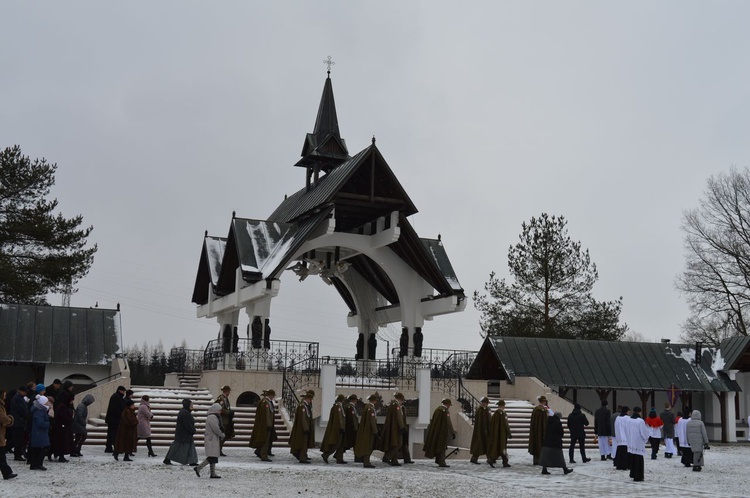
[0,145,96,304]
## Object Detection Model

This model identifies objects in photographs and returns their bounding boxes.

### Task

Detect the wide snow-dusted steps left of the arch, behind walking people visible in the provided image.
[86,386,289,448]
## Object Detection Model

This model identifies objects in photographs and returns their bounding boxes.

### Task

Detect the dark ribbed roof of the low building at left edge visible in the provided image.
[0,304,120,365]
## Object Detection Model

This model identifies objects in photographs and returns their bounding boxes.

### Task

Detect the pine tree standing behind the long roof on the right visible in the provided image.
[474,213,627,340]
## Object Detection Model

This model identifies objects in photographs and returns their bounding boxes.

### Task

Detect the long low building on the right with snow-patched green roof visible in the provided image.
[468,337,750,442]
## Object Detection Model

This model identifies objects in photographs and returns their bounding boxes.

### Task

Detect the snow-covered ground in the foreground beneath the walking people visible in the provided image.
[0,443,750,498]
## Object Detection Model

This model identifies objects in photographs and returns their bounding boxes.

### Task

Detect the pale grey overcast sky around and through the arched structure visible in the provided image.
[0,0,750,356]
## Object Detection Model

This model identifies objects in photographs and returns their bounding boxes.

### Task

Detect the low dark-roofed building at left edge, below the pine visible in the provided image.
[0,304,122,392]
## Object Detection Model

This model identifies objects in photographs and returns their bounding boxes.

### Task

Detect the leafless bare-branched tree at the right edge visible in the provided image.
[676,168,750,344]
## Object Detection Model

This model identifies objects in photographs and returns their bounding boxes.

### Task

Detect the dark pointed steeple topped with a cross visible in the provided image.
[295,60,350,188]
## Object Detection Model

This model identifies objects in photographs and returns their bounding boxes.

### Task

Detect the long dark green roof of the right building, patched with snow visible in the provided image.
[469,337,737,392]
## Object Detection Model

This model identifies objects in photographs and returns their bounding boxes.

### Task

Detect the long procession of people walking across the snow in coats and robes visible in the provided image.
[0,383,720,481]
